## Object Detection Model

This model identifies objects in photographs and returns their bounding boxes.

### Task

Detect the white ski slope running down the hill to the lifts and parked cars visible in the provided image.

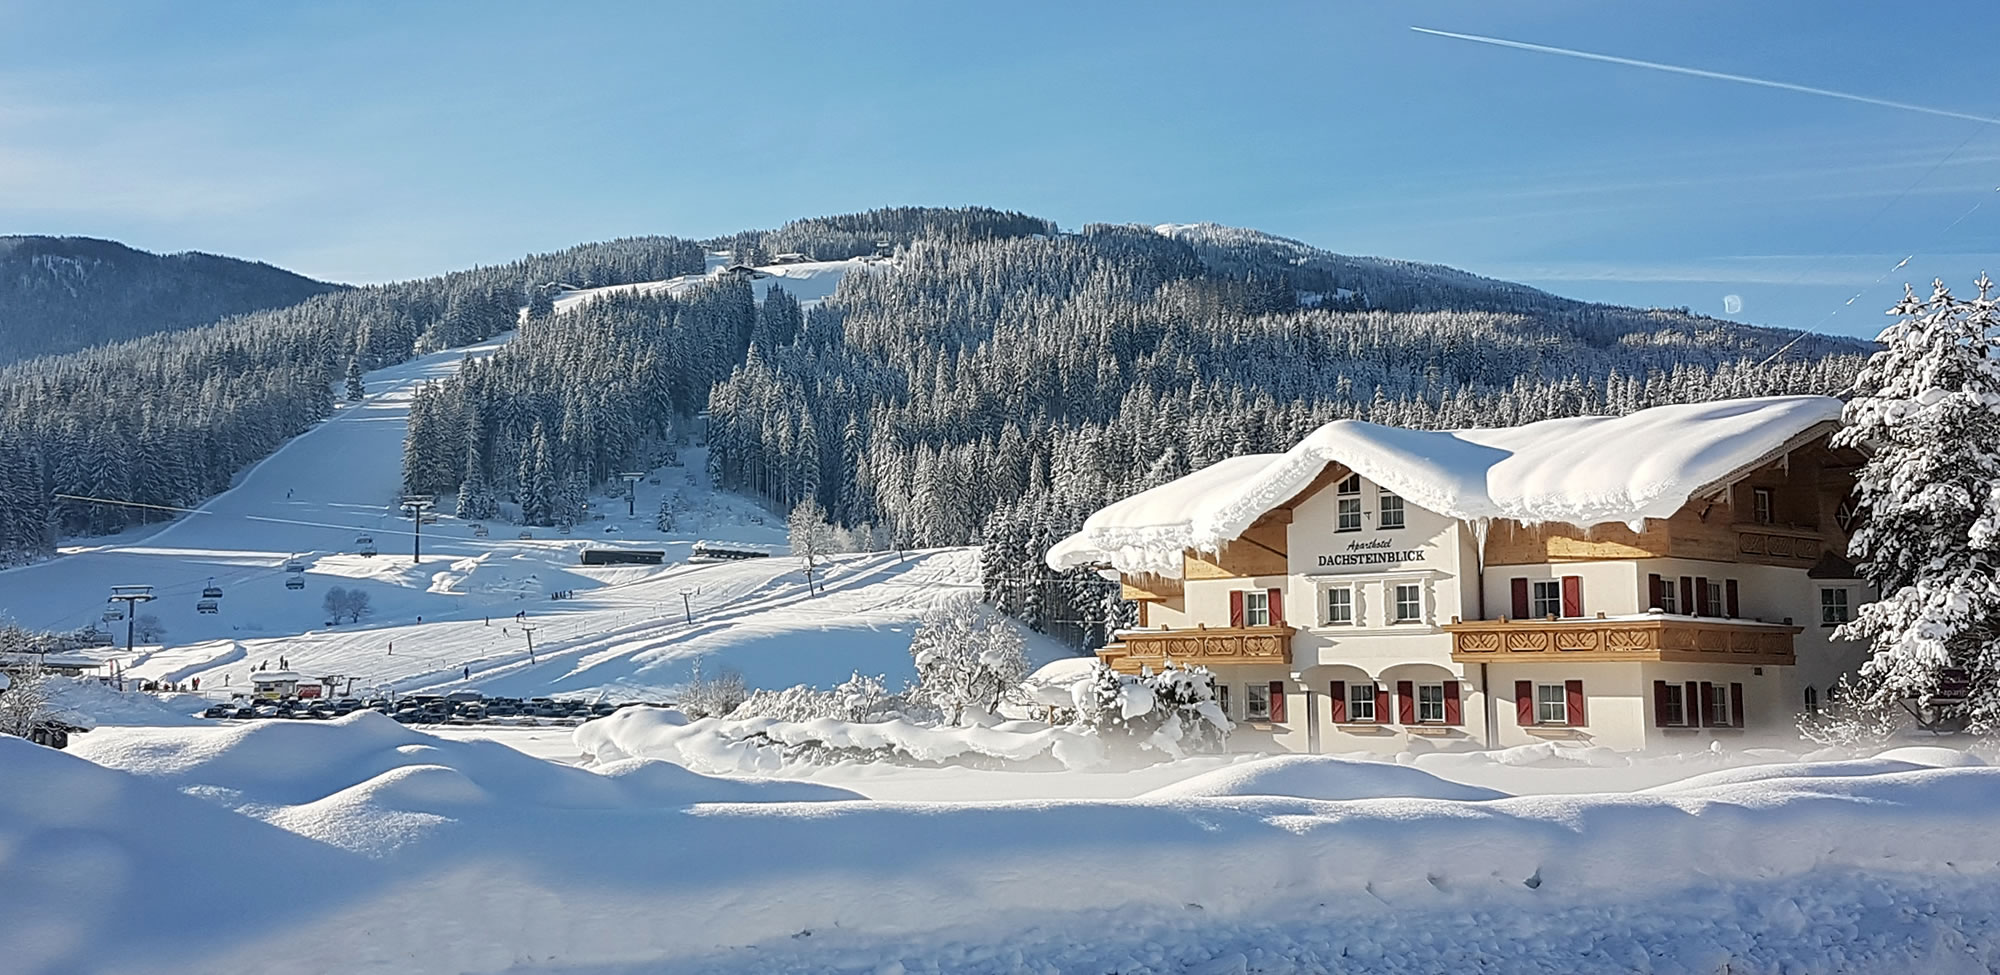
[0,303,1066,699]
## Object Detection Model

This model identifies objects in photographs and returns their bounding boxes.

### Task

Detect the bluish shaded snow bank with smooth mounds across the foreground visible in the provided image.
[0,713,2000,973]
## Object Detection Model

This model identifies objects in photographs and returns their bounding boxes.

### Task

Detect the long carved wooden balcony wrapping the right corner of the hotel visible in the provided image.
[1444,615,1804,667]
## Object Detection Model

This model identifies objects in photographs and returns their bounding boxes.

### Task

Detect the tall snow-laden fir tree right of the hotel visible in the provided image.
[1834,274,2000,733]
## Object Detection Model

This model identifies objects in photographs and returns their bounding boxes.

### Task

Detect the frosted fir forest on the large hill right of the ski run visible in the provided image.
[404,210,1864,643]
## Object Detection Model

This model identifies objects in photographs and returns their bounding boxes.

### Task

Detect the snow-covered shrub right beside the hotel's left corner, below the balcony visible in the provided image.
[1074,661,1234,759]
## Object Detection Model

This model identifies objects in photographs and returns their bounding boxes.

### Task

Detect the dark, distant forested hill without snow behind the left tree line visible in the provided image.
[0,236,340,364]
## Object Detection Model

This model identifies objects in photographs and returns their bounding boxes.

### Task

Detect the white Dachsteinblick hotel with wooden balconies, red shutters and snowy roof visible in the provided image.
[1048,396,1870,751]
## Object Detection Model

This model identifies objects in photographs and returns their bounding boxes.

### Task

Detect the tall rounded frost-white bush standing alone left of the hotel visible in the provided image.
[910,595,1028,725]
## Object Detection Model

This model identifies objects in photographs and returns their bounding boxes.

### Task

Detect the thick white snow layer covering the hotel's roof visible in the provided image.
[1048,396,1840,577]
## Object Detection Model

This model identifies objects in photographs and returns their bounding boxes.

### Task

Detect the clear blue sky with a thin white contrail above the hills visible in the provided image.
[0,0,2000,334]
